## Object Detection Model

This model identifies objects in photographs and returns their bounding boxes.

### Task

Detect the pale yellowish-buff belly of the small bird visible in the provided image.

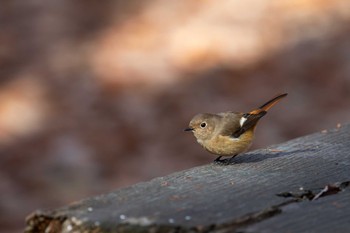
[200,132,253,156]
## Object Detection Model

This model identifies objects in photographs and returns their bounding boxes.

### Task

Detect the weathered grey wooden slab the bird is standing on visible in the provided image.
[26,125,350,232]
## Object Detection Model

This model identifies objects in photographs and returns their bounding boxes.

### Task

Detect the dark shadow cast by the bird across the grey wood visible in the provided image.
[232,148,316,164]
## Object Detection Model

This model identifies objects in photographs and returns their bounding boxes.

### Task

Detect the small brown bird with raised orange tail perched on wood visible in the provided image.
[185,93,287,164]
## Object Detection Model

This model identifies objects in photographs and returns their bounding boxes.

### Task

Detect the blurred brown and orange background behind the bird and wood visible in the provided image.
[0,0,350,233]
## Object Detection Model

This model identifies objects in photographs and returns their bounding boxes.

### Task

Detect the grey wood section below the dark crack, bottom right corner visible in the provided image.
[241,190,350,233]
